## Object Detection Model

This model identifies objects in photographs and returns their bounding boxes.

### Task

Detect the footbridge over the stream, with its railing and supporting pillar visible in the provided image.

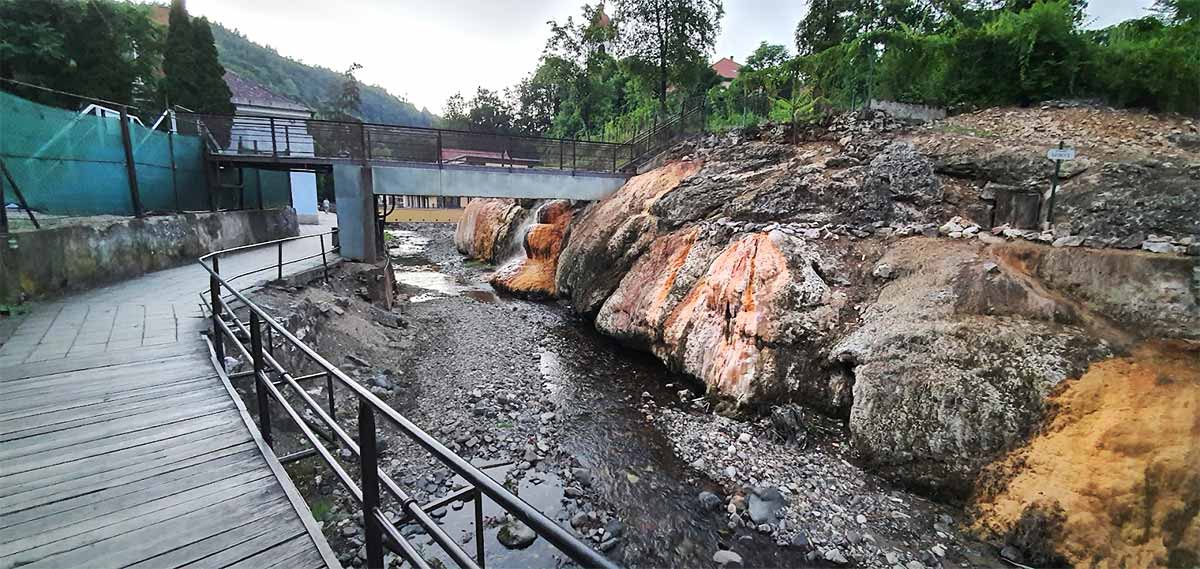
[179,107,703,262]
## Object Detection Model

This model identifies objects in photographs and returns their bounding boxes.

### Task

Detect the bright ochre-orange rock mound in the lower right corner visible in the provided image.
[976,342,1200,568]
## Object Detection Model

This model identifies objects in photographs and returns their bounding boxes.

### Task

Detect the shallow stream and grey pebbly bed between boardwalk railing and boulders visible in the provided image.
[226,226,1001,568]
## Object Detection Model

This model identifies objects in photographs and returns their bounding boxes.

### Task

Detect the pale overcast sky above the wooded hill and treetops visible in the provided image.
[166,0,1153,113]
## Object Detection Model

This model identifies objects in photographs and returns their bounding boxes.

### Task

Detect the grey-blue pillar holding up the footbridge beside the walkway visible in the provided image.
[334,164,378,263]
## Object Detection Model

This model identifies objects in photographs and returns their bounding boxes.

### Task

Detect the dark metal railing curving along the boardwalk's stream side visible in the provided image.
[199,235,617,569]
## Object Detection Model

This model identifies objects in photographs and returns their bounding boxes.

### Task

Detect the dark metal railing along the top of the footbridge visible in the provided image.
[178,113,636,173]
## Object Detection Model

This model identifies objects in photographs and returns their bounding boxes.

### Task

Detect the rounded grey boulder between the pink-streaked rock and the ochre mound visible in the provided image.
[832,238,1110,498]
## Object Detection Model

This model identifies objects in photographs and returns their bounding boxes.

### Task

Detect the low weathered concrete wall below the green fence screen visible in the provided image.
[0,208,299,304]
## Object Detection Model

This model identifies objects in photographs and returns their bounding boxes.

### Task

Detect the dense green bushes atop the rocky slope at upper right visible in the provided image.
[796,0,1200,113]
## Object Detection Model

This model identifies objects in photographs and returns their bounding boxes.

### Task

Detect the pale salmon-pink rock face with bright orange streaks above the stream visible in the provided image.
[662,233,791,400]
